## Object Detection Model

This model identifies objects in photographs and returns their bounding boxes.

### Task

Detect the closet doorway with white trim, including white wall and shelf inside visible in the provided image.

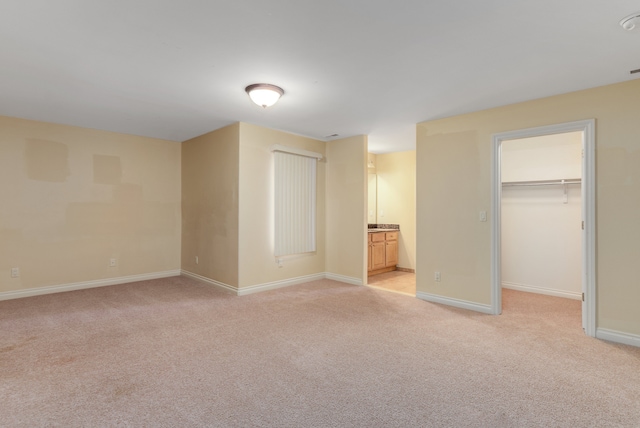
[491,120,596,336]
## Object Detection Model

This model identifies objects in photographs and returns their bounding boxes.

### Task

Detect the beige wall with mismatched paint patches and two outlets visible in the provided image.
[0,117,180,292]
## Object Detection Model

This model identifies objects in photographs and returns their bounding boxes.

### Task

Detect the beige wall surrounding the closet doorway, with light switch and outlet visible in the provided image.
[417,80,640,334]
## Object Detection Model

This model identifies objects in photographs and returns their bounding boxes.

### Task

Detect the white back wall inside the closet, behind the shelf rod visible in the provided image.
[501,132,582,299]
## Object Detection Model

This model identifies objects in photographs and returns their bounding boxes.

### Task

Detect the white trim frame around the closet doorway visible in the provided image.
[491,119,596,337]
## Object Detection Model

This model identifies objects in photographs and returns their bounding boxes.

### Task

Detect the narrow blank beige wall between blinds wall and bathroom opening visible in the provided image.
[326,135,367,284]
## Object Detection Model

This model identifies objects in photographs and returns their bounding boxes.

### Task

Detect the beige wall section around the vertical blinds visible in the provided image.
[238,123,326,288]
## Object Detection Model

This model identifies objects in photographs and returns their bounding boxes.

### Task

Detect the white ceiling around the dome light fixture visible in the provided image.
[0,0,640,153]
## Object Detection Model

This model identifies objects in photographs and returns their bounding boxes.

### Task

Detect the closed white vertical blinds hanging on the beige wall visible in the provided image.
[274,151,317,257]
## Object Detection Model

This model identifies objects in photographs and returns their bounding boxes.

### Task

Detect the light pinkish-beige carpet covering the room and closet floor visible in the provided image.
[0,277,640,427]
